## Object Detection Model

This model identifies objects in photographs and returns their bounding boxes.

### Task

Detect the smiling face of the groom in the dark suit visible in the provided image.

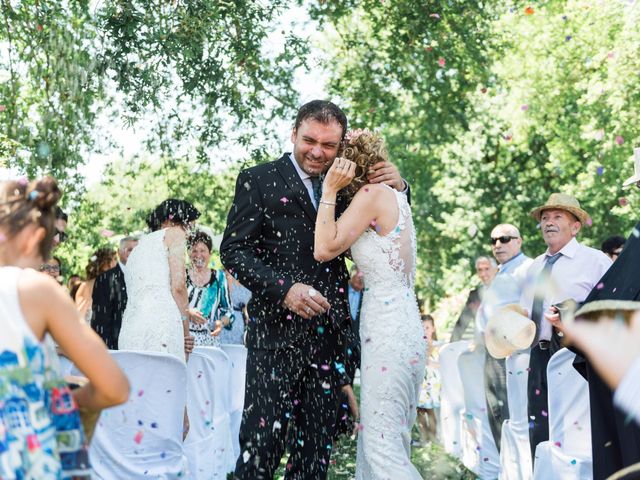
[291,119,342,177]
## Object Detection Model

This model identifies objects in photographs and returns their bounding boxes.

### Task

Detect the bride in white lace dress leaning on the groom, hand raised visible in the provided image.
[314,131,427,480]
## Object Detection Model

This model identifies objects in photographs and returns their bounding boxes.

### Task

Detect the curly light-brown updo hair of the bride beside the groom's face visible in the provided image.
[338,130,389,199]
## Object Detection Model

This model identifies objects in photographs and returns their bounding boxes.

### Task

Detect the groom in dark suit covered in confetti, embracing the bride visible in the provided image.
[220,100,404,480]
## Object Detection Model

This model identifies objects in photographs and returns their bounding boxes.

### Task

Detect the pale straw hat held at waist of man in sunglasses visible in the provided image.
[484,305,536,359]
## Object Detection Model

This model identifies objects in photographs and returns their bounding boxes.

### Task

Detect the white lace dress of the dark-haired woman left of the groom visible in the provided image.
[118,230,185,361]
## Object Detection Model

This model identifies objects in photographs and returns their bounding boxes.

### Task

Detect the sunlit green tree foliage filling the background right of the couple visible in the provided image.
[313,0,640,316]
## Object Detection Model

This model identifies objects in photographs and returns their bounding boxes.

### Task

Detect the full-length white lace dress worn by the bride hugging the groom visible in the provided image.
[351,189,427,480]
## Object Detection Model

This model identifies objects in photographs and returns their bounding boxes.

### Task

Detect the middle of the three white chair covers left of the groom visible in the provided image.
[184,347,236,480]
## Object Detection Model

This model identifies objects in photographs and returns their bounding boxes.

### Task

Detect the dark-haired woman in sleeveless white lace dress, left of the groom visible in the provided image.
[118,199,205,361]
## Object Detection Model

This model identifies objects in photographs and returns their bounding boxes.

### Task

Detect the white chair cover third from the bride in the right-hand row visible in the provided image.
[499,349,533,480]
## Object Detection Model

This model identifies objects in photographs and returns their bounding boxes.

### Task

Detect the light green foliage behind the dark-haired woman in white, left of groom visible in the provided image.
[55,159,239,275]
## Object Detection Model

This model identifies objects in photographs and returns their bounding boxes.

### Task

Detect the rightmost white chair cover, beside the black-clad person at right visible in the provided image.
[533,348,593,480]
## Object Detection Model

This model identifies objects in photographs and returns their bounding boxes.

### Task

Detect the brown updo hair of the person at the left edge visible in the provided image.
[0,177,62,260]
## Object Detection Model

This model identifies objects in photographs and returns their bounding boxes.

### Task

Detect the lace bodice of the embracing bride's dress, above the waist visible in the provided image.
[351,187,416,289]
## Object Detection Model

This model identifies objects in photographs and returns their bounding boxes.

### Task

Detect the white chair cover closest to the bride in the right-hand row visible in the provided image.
[440,340,471,457]
